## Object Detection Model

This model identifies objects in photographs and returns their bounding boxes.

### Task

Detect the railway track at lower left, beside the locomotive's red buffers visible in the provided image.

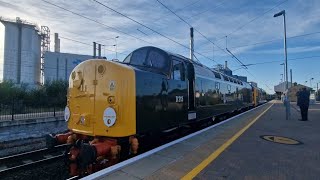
[0,144,67,174]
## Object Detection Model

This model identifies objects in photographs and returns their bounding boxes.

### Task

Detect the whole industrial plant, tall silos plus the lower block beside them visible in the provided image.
[0,17,92,88]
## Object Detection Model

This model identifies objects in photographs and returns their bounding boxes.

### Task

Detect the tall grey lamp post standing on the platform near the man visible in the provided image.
[273,10,290,120]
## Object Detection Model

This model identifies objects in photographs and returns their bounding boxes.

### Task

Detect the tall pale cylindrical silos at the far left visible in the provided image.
[0,17,41,86]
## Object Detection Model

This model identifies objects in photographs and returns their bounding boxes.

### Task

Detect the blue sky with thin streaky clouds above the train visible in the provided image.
[0,0,320,93]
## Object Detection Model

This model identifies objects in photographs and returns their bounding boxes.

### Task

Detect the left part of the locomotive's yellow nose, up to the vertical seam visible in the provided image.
[68,61,96,135]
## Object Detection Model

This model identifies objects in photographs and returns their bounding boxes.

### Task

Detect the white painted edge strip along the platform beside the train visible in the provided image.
[82,103,269,180]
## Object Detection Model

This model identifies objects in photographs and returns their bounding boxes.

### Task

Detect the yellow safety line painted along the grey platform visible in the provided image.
[181,104,273,180]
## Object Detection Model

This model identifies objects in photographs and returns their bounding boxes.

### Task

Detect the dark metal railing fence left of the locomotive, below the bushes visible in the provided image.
[0,102,64,121]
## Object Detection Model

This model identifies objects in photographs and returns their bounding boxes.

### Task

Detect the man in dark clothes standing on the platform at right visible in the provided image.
[297,87,310,121]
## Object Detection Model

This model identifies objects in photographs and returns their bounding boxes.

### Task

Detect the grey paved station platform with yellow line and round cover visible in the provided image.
[85,101,320,180]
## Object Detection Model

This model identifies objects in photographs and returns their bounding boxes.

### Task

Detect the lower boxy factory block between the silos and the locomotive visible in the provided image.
[44,52,92,82]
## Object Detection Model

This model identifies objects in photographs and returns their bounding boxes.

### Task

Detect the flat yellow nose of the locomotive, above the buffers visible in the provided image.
[65,60,136,137]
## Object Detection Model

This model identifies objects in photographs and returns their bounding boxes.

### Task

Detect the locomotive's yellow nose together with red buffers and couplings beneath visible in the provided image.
[47,59,138,176]
